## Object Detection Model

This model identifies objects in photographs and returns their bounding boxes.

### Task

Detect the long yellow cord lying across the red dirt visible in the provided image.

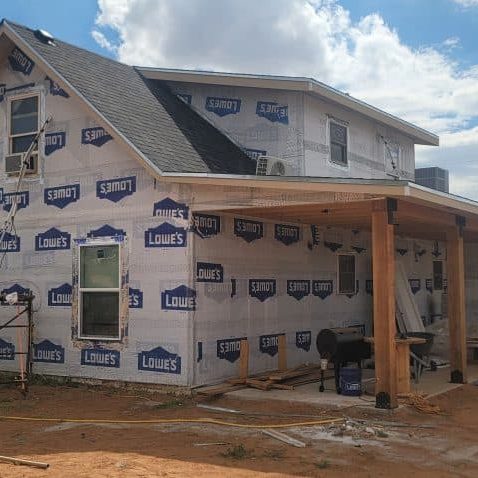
[0,415,344,430]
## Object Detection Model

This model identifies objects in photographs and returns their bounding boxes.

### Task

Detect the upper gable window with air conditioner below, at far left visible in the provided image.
[8,94,40,173]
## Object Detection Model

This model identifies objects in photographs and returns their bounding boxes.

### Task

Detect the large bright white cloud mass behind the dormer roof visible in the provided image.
[97,0,478,196]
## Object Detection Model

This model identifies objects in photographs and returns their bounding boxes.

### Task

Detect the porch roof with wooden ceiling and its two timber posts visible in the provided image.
[198,183,478,409]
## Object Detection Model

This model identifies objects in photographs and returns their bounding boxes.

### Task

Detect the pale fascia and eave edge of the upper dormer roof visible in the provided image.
[137,67,439,146]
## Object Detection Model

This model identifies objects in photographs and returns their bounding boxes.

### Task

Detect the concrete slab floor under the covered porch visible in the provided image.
[227,362,478,408]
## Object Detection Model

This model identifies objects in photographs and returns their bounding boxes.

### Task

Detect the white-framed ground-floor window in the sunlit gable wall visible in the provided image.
[78,244,121,340]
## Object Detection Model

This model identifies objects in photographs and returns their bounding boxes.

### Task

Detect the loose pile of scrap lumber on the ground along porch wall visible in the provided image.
[197,364,334,396]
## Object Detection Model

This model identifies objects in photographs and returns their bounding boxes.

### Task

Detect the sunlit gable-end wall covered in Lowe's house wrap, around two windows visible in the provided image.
[0,49,194,385]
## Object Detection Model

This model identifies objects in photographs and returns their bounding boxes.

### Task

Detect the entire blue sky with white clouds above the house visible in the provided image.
[1,0,478,200]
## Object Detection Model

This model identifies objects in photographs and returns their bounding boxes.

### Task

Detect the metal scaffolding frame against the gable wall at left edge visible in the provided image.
[0,292,35,395]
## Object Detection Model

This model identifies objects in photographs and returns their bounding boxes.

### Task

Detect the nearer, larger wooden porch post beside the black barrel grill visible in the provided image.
[372,199,398,408]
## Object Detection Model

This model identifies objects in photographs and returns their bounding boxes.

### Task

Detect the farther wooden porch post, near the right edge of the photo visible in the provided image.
[447,216,467,383]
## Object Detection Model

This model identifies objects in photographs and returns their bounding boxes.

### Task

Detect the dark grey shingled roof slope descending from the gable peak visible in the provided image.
[1,20,255,174]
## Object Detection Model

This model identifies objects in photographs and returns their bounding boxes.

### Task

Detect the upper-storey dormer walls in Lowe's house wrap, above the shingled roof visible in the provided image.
[169,82,415,180]
